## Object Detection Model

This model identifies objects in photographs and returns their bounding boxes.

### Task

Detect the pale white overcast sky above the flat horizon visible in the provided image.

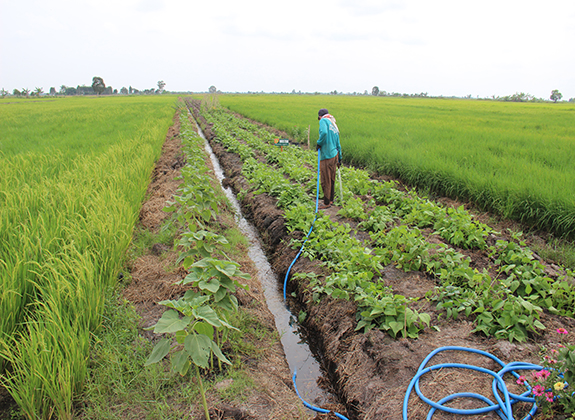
[0,0,575,99]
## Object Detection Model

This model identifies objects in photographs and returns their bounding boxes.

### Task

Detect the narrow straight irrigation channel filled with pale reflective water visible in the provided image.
[196,116,336,406]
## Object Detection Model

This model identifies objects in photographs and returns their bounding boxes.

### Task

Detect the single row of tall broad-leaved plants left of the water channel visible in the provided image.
[146,112,249,419]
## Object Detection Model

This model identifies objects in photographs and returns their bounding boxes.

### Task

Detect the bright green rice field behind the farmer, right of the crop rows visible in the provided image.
[219,95,575,238]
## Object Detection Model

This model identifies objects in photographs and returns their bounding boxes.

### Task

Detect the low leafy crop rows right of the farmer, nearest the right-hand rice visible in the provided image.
[338,167,575,341]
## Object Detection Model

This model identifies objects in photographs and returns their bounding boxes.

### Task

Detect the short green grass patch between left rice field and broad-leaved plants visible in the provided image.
[78,292,197,419]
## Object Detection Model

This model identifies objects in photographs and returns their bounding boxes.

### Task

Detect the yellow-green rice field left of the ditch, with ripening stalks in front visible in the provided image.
[0,95,175,419]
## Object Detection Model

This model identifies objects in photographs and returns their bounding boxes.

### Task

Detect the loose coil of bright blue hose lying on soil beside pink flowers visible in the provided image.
[403,346,543,420]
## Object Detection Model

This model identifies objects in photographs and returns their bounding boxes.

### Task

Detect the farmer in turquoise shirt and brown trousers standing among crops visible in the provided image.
[317,108,341,209]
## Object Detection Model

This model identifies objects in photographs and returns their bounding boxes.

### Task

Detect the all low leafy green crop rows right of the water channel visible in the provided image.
[195,103,575,341]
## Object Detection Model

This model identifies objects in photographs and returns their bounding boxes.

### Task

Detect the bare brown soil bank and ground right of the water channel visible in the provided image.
[190,101,575,420]
